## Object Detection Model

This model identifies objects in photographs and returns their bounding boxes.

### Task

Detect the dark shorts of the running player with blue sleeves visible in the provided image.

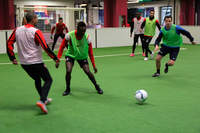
[158,45,180,61]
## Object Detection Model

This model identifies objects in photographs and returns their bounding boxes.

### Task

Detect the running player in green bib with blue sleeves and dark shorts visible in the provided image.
[152,16,195,77]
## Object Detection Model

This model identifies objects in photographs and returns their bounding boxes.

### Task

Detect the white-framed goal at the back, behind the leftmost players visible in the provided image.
[16,6,86,32]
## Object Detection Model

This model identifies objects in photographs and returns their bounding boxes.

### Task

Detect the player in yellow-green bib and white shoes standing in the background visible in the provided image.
[141,10,161,61]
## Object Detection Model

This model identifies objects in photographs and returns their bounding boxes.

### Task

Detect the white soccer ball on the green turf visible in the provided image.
[135,90,148,104]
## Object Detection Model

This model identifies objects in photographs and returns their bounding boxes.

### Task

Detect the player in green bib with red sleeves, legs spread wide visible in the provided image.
[56,22,103,96]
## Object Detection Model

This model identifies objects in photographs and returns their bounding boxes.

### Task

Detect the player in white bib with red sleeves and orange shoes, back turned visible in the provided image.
[7,12,59,113]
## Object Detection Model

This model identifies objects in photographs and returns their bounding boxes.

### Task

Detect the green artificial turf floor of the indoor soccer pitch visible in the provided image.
[0,45,200,133]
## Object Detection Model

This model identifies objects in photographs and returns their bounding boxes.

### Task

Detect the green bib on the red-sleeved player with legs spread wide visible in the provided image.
[65,31,89,60]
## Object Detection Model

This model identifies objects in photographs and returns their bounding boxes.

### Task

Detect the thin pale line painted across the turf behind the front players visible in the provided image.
[0,48,187,65]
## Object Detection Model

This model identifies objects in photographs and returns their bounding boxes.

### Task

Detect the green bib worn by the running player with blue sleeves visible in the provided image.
[161,24,183,47]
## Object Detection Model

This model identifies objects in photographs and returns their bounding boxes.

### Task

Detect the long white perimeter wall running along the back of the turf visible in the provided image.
[0,26,200,53]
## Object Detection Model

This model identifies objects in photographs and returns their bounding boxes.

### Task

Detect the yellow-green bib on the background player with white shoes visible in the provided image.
[144,18,156,36]
